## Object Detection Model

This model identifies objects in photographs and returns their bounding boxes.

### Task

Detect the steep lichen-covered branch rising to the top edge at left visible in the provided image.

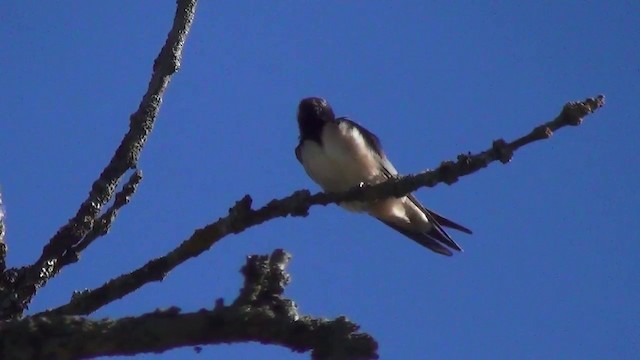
[0,0,197,318]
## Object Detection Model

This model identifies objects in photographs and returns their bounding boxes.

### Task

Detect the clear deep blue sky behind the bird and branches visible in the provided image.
[0,0,640,359]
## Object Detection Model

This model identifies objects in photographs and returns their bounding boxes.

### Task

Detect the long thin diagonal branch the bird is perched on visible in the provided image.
[49,96,604,315]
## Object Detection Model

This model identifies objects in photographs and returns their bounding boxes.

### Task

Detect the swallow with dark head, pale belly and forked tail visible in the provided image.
[296,97,471,256]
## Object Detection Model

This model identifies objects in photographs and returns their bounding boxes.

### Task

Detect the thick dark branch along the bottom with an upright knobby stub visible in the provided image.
[8,250,378,360]
